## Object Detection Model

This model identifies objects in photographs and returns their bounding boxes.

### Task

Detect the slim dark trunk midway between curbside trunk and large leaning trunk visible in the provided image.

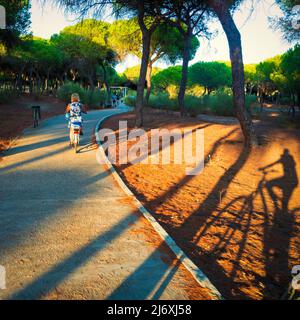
[178,30,191,117]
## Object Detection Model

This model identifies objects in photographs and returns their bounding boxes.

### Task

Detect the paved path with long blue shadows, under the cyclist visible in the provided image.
[0,110,209,299]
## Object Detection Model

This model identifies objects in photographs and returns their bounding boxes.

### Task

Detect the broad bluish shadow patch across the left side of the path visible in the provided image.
[0,170,113,257]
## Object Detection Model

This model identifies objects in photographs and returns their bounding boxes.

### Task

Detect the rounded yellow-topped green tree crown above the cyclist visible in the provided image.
[51,19,117,88]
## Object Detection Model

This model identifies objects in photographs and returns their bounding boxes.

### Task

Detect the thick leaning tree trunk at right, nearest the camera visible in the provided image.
[209,0,257,146]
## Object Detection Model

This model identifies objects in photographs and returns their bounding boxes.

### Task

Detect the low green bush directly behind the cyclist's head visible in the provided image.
[58,82,106,108]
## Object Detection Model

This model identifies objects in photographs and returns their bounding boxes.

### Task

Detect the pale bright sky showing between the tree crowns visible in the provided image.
[31,0,291,72]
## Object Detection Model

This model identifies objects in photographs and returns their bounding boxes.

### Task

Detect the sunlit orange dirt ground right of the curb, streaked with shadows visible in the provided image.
[104,112,300,299]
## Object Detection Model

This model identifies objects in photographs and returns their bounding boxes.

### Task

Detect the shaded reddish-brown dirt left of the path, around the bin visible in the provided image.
[0,95,65,161]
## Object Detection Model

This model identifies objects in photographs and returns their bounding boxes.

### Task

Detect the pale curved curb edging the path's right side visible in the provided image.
[95,111,224,300]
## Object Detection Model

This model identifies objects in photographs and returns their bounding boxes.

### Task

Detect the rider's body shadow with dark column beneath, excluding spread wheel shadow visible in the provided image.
[261,149,299,299]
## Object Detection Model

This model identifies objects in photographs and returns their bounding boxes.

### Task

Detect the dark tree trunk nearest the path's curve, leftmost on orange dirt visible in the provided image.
[135,30,151,127]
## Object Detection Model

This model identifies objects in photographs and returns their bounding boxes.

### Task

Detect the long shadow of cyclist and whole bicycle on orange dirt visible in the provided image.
[211,149,298,299]
